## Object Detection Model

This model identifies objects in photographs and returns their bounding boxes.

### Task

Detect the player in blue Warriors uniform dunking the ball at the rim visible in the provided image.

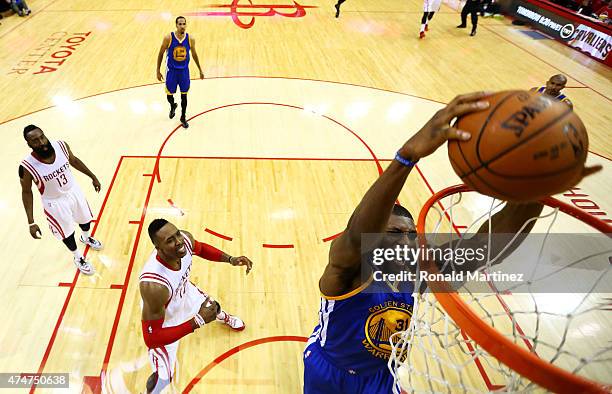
[304,93,542,394]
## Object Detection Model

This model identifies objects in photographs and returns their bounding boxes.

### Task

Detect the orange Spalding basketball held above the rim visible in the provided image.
[448,91,589,201]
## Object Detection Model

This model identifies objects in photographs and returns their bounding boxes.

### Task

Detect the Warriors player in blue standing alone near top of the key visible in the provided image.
[157,16,204,128]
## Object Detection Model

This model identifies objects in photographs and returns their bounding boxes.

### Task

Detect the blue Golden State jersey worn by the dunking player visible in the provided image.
[307,278,414,374]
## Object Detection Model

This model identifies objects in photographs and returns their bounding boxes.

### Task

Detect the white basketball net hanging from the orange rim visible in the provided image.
[389,189,612,394]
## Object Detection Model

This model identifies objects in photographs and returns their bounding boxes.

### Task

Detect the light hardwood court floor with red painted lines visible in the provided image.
[0,0,612,393]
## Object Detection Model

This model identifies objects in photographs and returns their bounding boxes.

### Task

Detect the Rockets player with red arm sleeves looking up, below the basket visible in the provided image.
[140,219,253,394]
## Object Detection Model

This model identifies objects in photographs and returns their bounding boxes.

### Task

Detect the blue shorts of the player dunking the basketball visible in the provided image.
[304,343,393,394]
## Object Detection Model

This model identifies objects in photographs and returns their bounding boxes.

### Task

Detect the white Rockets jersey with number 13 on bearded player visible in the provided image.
[21,141,76,199]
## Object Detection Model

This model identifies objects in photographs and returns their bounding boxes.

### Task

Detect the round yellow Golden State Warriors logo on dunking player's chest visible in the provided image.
[362,301,412,360]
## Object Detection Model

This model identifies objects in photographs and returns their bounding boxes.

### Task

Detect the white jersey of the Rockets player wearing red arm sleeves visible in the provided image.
[140,233,206,327]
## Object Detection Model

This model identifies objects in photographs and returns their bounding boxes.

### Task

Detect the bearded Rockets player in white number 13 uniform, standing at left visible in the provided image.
[19,125,102,275]
